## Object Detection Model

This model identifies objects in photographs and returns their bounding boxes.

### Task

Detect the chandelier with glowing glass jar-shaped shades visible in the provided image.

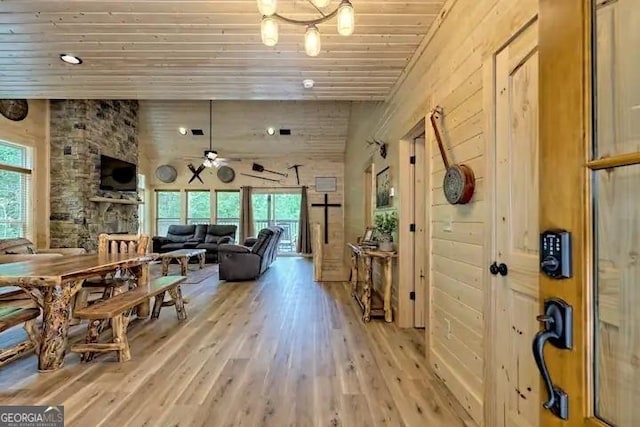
[258,0,355,56]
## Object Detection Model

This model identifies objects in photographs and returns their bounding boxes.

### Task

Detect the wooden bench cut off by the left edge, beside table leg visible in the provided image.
[0,306,40,366]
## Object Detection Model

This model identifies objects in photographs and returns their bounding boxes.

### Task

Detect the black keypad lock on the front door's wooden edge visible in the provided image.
[540,229,571,279]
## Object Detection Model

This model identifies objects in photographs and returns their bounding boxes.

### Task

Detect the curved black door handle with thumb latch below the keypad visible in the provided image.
[533,298,573,420]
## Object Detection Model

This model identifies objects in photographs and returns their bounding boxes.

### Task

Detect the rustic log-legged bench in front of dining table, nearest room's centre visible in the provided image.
[71,276,187,362]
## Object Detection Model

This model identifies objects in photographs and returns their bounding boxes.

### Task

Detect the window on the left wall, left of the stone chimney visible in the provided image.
[0,141,31,239]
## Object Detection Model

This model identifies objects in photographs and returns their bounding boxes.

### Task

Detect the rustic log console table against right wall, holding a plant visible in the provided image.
[348,243,398,322]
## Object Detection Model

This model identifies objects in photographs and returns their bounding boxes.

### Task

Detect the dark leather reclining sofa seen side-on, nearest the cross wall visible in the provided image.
[218,226,284,281]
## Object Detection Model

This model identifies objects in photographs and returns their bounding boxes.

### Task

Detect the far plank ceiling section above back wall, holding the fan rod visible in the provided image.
[140,100,351,160]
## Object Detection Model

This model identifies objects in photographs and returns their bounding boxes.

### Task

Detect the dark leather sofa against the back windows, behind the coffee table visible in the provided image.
[152,224,238,262]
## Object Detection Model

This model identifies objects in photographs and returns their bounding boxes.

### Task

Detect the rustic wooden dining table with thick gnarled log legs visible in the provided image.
[0,254,157,372]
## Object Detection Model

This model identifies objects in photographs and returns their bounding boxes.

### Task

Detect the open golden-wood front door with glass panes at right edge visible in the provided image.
[538,0,640,427]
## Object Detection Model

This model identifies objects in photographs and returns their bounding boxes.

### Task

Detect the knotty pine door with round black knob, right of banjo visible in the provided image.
[490,22,539,427]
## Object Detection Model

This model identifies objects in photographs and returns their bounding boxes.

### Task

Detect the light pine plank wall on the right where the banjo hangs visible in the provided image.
[346,0,538,425]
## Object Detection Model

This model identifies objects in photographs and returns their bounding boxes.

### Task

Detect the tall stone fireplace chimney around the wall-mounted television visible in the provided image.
[50,100,138,251]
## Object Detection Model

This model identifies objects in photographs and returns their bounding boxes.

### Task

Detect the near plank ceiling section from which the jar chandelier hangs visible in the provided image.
[0,0,444,100]
